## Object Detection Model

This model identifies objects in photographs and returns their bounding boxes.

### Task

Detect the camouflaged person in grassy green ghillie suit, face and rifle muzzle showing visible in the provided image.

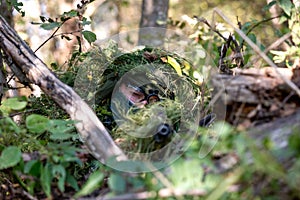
[75,42,214,159]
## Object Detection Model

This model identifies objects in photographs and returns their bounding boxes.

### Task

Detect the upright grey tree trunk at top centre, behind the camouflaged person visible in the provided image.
[138,0,169,47]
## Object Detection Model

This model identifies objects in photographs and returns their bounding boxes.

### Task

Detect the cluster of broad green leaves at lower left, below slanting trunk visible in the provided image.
[0,98,83,197]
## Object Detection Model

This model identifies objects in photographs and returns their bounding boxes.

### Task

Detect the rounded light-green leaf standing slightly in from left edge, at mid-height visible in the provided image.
[26,114,49,134]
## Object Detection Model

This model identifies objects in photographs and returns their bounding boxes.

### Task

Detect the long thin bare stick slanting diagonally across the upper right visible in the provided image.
[214,8,300,97]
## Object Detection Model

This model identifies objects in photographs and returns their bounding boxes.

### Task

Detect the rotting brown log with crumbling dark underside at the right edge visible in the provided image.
[212,67,300,128]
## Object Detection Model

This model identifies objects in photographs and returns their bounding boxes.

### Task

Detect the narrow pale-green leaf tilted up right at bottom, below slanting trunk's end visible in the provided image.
[74,171,104,198]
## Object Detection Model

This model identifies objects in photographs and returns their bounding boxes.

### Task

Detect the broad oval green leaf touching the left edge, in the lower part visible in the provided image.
[0,146,22,170]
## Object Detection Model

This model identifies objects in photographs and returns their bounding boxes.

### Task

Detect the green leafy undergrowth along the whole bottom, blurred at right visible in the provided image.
[0,95,300,199]
